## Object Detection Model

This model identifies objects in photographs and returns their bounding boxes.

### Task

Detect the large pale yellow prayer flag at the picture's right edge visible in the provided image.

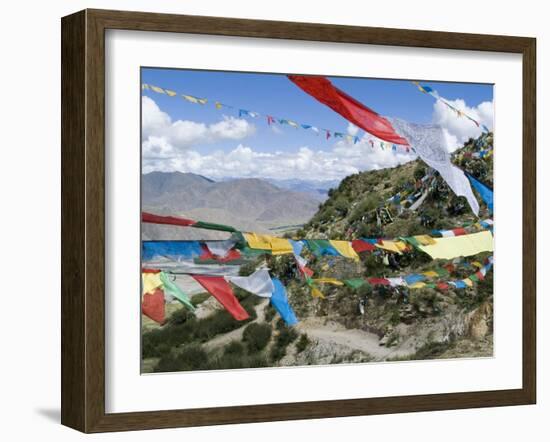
[420,230,493,259]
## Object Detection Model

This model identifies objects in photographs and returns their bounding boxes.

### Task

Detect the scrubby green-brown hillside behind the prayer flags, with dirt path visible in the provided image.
[144,134,493,371]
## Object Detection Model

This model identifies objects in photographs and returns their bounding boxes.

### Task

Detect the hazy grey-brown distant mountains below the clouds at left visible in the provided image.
[141,172,319,239]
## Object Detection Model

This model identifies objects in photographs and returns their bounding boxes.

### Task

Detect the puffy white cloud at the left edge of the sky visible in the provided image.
[142,97,255,158]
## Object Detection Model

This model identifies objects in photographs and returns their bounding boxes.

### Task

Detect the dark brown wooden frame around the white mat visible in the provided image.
[61,10,536,432]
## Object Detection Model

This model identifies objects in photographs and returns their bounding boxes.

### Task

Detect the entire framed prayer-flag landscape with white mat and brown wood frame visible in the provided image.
[61,10,536,432]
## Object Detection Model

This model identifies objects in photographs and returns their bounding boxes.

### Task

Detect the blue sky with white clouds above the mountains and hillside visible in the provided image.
[142,68,493,179]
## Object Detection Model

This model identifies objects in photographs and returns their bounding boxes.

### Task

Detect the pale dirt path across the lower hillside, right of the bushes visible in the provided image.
[296,318,411,361]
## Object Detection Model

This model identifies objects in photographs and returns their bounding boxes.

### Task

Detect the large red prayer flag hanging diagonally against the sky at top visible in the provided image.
[288,75,409,146]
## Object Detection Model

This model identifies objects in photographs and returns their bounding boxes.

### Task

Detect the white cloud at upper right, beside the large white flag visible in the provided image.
[432,99,494,150]
